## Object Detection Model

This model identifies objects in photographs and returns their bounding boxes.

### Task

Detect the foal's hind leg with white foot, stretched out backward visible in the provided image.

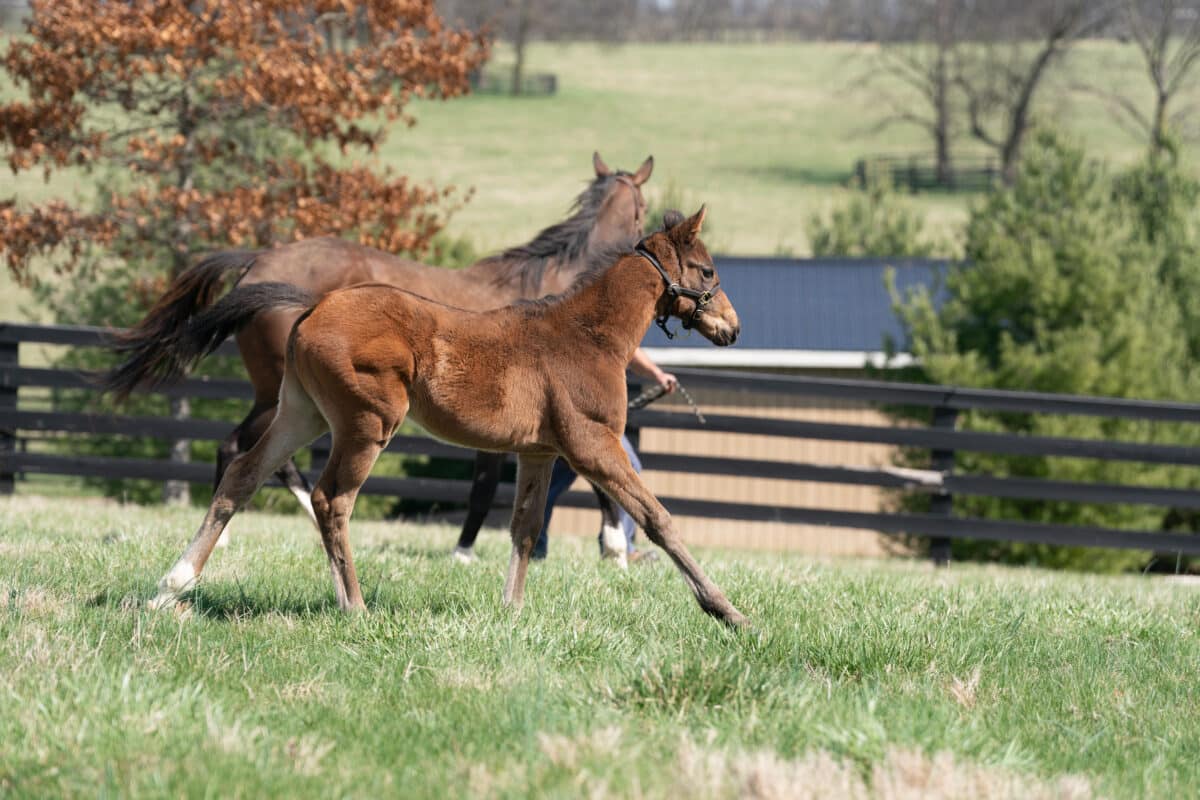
[150,385,325,608]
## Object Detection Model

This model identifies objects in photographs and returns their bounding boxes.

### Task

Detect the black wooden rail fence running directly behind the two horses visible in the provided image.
[0,323,1200,561]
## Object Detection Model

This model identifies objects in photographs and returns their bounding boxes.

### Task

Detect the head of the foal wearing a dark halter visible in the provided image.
[637,206,742,347]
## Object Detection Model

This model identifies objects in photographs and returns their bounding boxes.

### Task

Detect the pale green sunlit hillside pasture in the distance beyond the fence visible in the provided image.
[0,42,1200,319]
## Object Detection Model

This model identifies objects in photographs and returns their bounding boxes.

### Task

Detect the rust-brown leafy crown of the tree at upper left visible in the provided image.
[0,0,487,282]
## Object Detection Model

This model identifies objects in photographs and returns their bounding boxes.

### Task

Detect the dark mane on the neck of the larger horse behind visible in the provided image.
[479,172,630,294]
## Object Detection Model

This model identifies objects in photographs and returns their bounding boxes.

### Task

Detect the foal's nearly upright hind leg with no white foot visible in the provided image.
[312,434,386,612]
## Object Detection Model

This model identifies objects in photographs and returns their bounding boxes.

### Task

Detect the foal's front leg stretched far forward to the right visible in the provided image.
[566,428,748,625]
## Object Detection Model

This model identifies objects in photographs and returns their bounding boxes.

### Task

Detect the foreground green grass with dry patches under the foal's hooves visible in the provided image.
[0,498,1200,798]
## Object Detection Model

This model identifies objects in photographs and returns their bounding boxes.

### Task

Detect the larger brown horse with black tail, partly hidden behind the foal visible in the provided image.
[102,152,654,544]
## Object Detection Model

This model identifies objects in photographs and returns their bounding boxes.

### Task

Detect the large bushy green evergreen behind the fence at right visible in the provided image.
[899,132,1200,570]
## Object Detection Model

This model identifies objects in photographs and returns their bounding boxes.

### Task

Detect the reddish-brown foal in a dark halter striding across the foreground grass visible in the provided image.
[151,209,746,625]
